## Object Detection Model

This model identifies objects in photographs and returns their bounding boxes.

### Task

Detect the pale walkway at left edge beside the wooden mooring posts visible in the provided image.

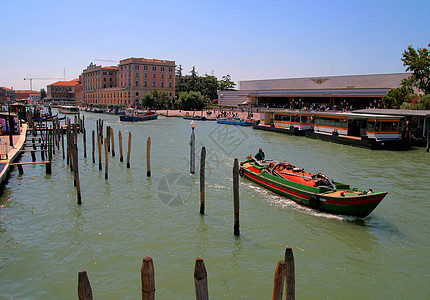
[0,124,27,184]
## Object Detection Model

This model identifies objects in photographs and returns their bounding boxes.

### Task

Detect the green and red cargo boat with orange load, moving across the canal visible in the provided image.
[239,156,387,218]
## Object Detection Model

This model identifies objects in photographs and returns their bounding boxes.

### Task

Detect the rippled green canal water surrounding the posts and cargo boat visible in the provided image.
[0,113,430,299]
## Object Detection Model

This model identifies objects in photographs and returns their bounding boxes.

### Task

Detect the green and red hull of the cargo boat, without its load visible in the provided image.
[240,165,387,218]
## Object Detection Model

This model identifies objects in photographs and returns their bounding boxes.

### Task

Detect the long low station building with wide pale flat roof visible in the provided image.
[218,73,410,109]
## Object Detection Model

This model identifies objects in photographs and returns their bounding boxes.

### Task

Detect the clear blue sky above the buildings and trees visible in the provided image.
[0,0,430,90]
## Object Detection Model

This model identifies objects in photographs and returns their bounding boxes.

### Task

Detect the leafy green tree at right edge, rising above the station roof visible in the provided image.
[402,44,430,95]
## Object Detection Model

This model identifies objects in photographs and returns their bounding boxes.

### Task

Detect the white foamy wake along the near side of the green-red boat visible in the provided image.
[242,182,350,221]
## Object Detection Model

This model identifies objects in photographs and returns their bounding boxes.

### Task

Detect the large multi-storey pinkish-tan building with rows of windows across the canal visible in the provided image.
[80,58,175,105]
